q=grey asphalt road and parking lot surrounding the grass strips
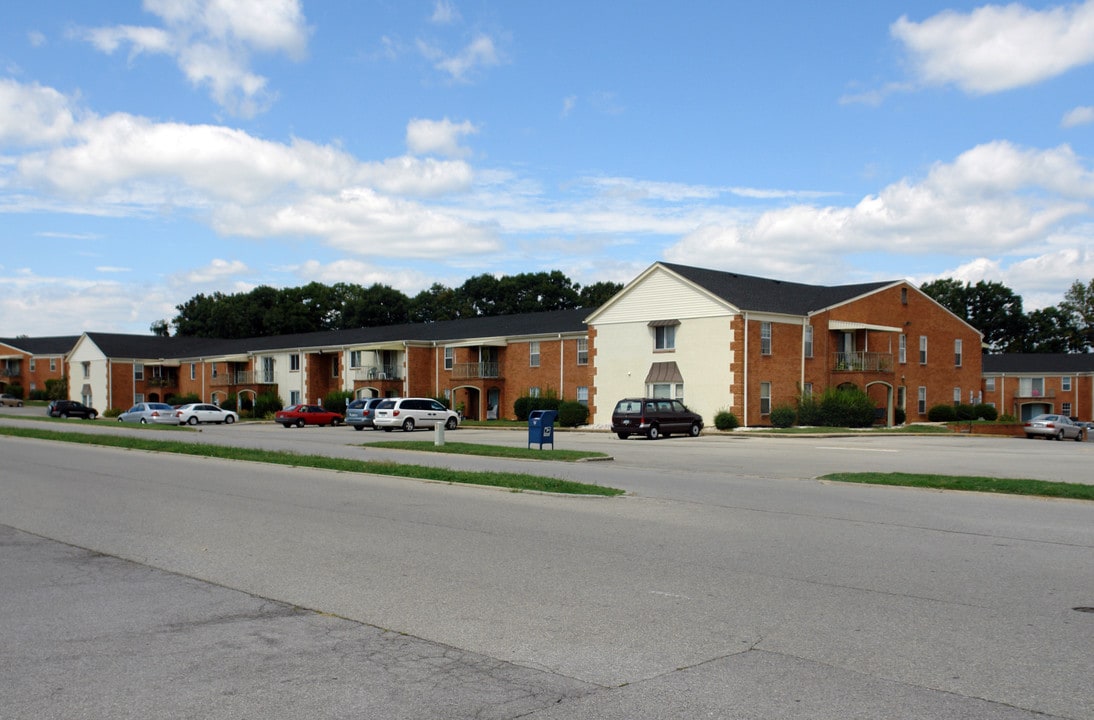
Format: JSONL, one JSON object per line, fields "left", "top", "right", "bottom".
{"left": 6, "top": 411, "right": 1094, "bottom": 719}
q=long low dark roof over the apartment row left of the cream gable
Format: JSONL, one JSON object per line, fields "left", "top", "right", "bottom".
{"left": 70, "top": 309, "right": 590, "bottom": 359}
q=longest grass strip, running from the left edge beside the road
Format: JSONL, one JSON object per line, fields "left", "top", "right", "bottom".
{"left": 0, "top": 428, "right": 624, "bottom": 497}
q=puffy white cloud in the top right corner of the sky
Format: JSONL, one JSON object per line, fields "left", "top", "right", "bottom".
{"left": 891, "top": 0, "right": 1094, "bottom": 94}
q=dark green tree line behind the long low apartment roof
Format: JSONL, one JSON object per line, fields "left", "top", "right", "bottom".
{"left": 160, "top": 270, "right": 622, "bottom": 339}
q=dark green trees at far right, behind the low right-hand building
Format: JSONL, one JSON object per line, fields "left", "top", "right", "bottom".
{"left": 920, "top": 278, "right": 1094, "bottom": 352}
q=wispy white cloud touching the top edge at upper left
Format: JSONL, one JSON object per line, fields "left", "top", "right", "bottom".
{"left": 78, "top": 0, "right": 309, "bottom": 117}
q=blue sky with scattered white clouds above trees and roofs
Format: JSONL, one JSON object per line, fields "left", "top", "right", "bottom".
{"left": 0, "top": 0, "right": 1094, "bottom": 337}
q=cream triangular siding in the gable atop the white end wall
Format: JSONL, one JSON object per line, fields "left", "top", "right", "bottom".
{"left": 594, "top": 268, "right": 732, "bottom": 323}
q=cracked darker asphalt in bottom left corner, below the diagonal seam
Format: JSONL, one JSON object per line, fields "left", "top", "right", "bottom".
{"left": 0, "top": 525, "right": 597, "bottom": 720}
